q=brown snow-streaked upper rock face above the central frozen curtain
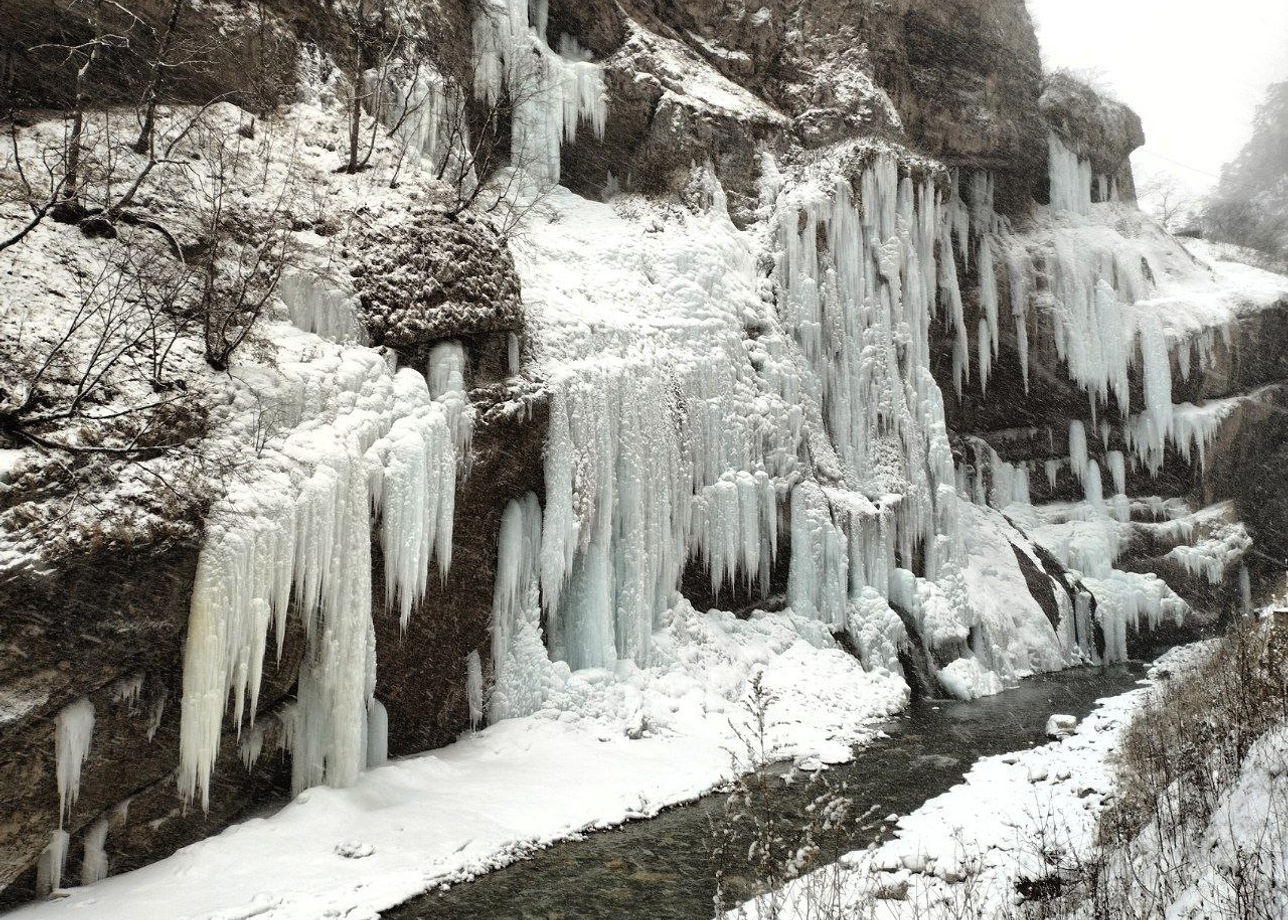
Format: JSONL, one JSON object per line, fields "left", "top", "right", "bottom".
{"left": 561, "top": 0, "right": 1046, "bottom": 219}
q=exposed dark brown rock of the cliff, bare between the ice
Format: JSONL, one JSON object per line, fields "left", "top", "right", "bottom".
{"left": 0, "top": 0, "right": 1288, "bottom": 901}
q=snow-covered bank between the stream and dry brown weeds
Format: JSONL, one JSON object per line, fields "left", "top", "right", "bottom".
{"left": 729, "top": 643, "right": 1211, "bottom": 920}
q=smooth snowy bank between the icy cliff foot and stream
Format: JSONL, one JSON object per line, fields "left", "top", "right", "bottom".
{"left": 13, "top": 607, "right": 907, "bottom": 920}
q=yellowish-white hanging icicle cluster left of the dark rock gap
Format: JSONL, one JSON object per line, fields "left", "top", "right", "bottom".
{"left": 179, "top": 327, "right": 456, "bottom": 807}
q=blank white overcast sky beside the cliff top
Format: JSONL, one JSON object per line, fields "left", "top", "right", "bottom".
{"left": 1028, "top": 0, "right": 1288, "bottom": 189}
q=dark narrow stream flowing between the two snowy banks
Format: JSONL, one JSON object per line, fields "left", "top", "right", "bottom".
{"left": 381, "top": 665, "right": 1144, "bottom": 920}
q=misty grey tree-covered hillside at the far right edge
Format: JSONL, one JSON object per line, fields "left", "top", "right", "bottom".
{"left": 1203, "top": 81, "right": 1288, "bottom": 258}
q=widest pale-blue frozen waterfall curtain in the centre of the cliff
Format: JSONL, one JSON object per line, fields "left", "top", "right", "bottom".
{"left": 492, "top": 152, "right": 1068, "bottom": 719}
